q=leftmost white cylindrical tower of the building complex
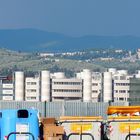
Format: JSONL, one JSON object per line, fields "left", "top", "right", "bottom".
{"left": 15, "top": 71, "right": 24, "bottom": 101}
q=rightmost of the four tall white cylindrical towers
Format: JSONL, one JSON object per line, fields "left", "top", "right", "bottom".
{"left": 103, "top": 72, "right": 112, "bottom": 102}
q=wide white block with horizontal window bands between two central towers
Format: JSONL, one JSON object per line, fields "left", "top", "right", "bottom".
{"left": 51, "top": 78, "right": 82, "bottom": 101}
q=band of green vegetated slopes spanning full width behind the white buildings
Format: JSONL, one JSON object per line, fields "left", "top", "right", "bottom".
{"left": 0, "top": 49, "right": 140, "bottom": 77}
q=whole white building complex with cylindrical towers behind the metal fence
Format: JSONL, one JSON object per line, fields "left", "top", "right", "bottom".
{"left": 0, "top": 68, "right": 140, "bottom": 102}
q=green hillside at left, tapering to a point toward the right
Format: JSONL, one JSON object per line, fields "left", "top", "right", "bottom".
{"left": 0, "top": 49, "right": 104, "bottom": 76}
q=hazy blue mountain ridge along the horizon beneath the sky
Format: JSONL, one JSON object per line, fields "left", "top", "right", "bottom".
{"left": 0, "top": 29, "right": 140, "bottom": 52}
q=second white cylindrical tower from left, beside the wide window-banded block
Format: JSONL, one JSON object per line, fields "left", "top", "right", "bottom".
{"left": 40, "top": 71, "right": 50, "bottom": 102}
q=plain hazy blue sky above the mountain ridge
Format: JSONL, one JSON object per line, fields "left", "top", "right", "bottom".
{"left": 0, "top": 0, "right": 140, "bottom": 36}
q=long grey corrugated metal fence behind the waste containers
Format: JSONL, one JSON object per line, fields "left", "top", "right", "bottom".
{"left": 0, "top": 101, "right": 128, "bottom": 118}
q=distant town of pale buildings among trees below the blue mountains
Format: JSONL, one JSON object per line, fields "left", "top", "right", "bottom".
{"left": 39, "top": 49, "right": 140, "bottom": 62}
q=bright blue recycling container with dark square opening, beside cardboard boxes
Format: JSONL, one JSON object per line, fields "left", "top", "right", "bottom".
{"left": 0, "top": 109, "right": 39, "bottom": 140}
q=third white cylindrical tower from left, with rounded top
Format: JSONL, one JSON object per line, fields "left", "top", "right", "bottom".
{"left": 82, "top": 69, "right": 92, "bottom": 102}
